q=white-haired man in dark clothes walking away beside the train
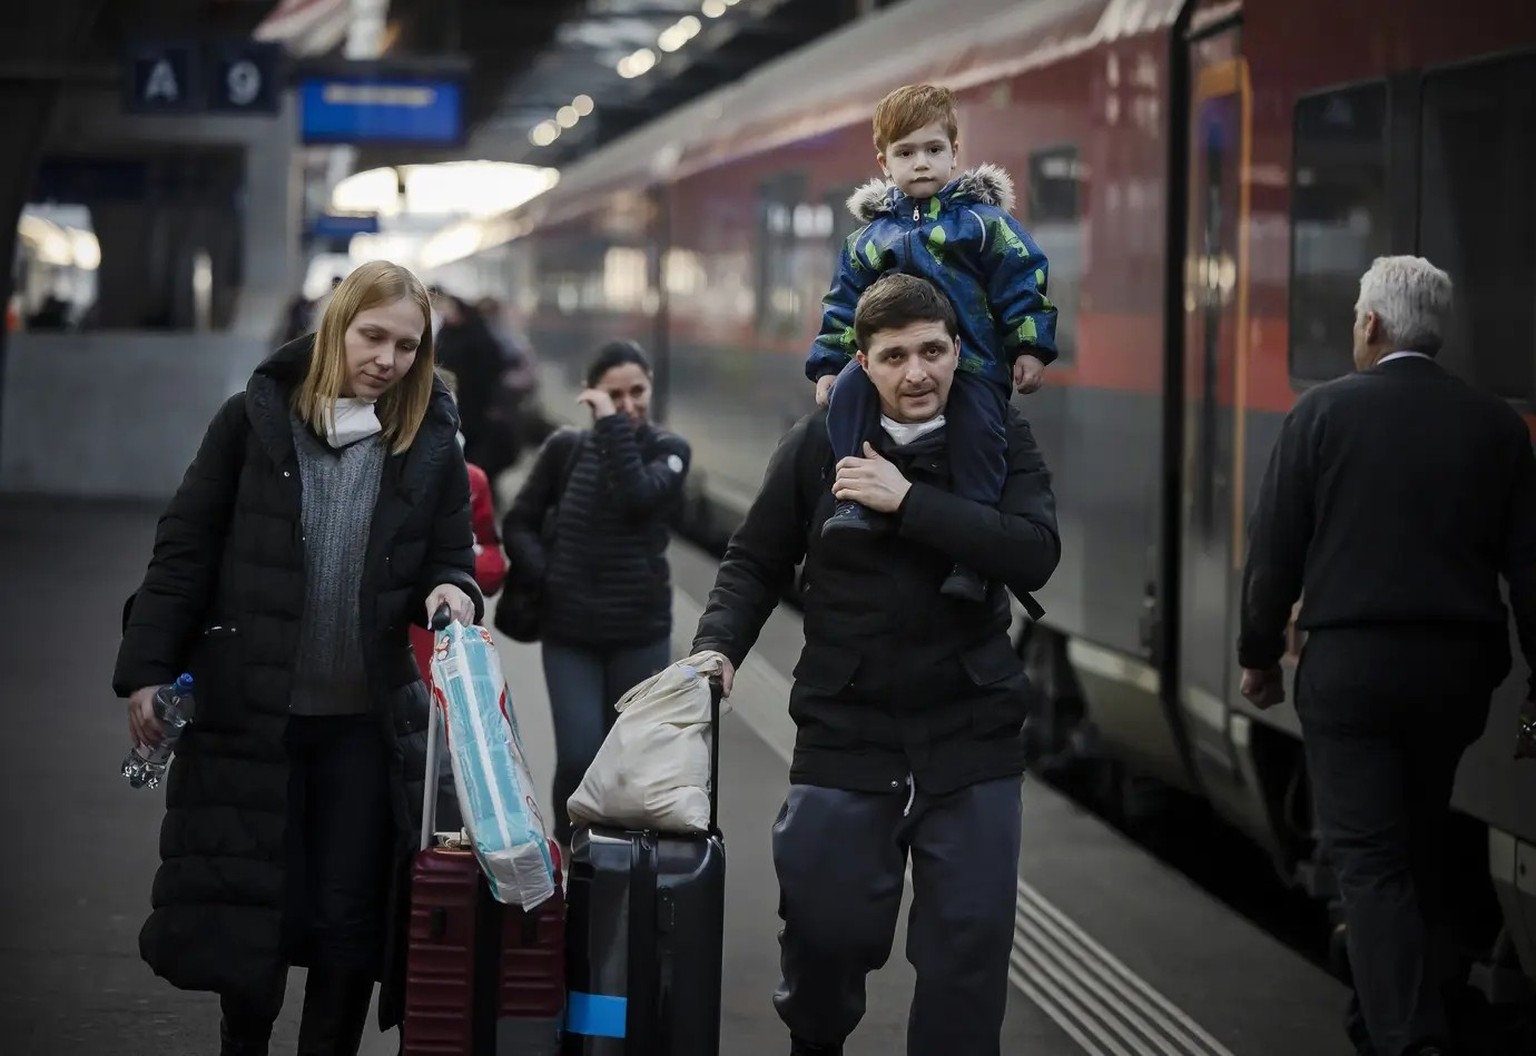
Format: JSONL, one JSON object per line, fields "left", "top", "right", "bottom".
{"left": 1238, "top": 256, "right": 1536, "bottom": 1056}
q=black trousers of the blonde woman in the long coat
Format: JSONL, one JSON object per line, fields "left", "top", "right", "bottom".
{"left": 223, "top": 715, "right": 393, "bottom": 1025}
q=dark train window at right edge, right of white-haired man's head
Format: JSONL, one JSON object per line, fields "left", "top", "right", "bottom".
{"left": 1419, "top": 55, "right": 1536, "bottom": 399}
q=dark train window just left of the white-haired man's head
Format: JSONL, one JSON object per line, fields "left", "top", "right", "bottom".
{"left": 1290, "top": 83, "right": 1390, "bottom": 382}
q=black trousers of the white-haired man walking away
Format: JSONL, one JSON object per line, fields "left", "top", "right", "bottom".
{"left": 1296, "top": 628, "right": 1510, "bottom": 1056}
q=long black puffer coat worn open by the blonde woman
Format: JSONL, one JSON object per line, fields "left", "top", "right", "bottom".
{"left": 112, "top": 336, "right": 482, "bottom": 1027}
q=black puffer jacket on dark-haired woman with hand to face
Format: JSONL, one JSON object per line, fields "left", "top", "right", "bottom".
{"left": 501, "top": 414, "right": 690, "bottom": 646}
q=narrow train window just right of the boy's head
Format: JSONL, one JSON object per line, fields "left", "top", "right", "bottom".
{"left": 1025, "top": 146, "right": 1086, "bottom": 362}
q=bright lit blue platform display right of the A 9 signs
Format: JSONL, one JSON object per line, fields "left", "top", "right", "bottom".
{"left": 300, "top": 77, "right": 464, "bottom": 146}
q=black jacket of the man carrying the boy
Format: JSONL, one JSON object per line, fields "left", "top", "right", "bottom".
{"left": 694, "top": 411, "right": 1060, "bottom": 795}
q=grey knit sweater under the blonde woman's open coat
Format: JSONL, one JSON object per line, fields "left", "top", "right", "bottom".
{"left": 289, "top": 417, "right": 384, "bottom": 715}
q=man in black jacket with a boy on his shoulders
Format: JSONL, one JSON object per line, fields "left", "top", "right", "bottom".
{"left": 693, "top": 273, "right": 1060, "bottom": 1056}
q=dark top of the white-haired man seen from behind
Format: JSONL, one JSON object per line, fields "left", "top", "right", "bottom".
{"left": 1238, "top": 349, "right": 1536, "bottom": 695}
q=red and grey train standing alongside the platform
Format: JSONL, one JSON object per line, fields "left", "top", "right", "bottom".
{"left": 456, "top": 0, "right": 1536, "bottom": 976}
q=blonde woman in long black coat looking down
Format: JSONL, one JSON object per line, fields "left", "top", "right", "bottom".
{"left": 114, "top": 261, "right": 484, "bottom": 1056}
